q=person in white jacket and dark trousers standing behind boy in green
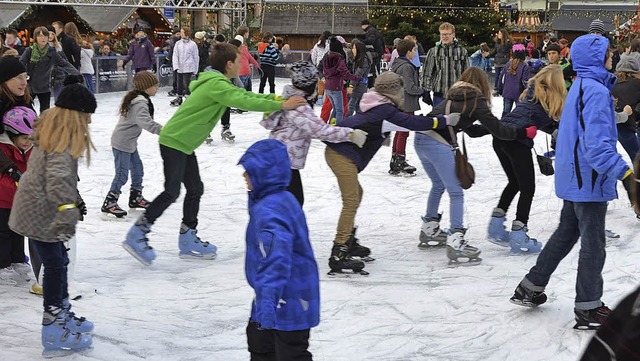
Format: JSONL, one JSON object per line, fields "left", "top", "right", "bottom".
{"left": 171, "top": 26, "right": 200, "bottom": 107}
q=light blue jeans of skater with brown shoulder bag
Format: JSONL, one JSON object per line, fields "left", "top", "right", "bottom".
{"left": 414, "top": 133, "right": 464, "bottom": 229}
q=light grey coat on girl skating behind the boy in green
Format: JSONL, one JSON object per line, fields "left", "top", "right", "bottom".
{"left": 111, "top": 95, "right": 162, "bottom": 153}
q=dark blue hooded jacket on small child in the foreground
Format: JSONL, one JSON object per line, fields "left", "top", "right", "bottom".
{"left": 238, "top": 139, "right": 320, "bottom": 331}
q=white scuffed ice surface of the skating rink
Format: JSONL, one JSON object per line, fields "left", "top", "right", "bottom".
{"left": 0, "top": 79, "right": 640, "bottom": 361}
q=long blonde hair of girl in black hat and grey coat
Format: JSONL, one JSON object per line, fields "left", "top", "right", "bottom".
{"left": 32, "top": 107, "right": 96, "bottom": 164}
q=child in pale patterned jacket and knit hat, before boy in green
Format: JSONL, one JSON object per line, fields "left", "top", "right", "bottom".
{"left": 260, "top": 61, "right": 367, "bottom": 206}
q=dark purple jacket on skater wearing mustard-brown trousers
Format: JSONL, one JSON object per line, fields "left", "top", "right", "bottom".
{"left": 325, "top": 90, "right": 447, "bottom": 173}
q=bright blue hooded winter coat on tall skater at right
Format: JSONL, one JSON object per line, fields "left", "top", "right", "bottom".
{"left": 555, "top": 34, "right": 629, "bottom": 202}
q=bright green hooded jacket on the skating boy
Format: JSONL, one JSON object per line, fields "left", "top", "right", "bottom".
{"left": 160, "top": 70, "right": 282, "bottom": 154}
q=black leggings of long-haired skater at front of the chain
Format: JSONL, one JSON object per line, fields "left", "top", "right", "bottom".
{"left": 493, "top": 138, "right": 536, "bottom": 224}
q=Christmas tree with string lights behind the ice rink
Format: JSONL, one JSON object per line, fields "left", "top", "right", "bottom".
{"left": 369, "top": 0, "right": 510, "bottom": 50}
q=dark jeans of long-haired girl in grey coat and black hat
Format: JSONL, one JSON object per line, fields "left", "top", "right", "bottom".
{"left": 33, "top": 240, "right": 69, "bottom": 310}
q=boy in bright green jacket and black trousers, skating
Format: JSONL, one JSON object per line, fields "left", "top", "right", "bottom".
{"left": 122, "top": 43, "right": 307, "bottom": 265}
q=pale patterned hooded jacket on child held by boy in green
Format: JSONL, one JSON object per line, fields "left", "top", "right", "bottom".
{"left": 260, "top": 85, "right": 353, "bottom": 169}
